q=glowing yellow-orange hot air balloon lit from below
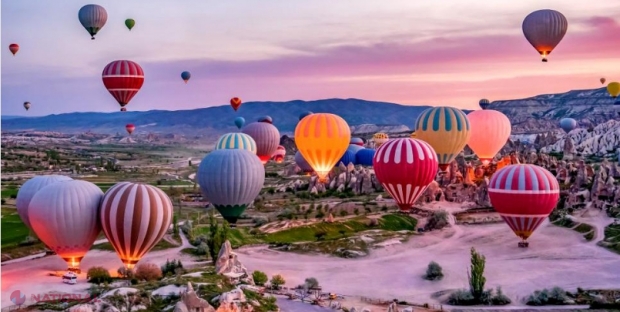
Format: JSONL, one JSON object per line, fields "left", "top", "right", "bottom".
{"left": 295, "top": 113, "right": 351, "bottom": 182}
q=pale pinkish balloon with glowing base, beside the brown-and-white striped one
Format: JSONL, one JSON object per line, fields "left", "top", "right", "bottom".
{"left": 28, "top": 180, "right": 103, "bottom": 270}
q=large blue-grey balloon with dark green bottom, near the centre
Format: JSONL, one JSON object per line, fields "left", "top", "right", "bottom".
{"left": 196, "top": 149, "right": 265, "bottom": 224}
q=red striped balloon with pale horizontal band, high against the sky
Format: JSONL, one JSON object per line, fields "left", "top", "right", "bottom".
{"left": 101, "top": 60, "right": 144, "bottom": 111}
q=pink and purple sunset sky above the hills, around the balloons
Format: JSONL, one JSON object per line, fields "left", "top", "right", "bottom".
{"left": 1, "top": 0, "right": 620, "bottom": 116}
